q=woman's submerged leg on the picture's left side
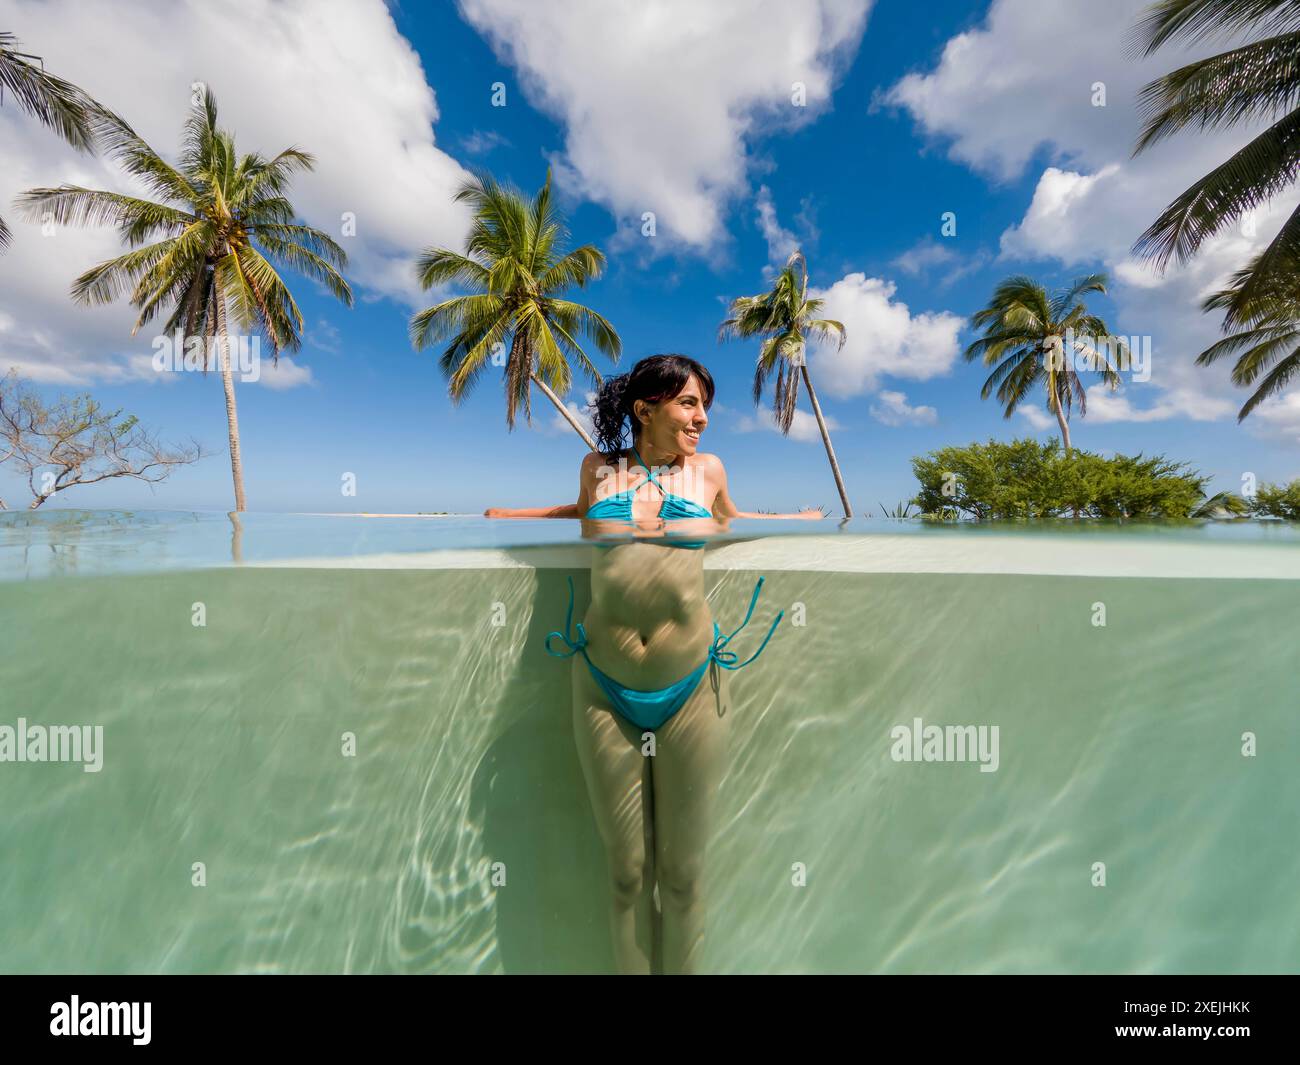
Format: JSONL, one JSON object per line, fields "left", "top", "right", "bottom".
{"left": 573, "top": 654, "right": 655, "bottom": 974}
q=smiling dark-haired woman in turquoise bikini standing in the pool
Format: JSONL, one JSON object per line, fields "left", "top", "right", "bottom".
{"left": 486, "top": 355, "right": 822, "bottom": 973}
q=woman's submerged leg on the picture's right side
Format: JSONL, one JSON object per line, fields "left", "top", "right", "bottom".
{"left": 654, "top": 666, "right": 731, "bottom": 973}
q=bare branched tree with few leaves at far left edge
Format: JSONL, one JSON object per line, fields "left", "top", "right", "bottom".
{"left": 0, "top": 371, "right": 203, "bottom": 510}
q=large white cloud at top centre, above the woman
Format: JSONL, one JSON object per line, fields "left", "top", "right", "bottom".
{"left": 460, "top": 0, "right": 871, "bottom": 252}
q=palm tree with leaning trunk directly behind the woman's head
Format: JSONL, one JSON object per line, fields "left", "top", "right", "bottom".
{"left": 411, "top": 170, "right": 623, "bottom": 451}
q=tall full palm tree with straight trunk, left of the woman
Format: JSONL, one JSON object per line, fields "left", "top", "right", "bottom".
{"left": 18, "top": 90, "right": 352, "bottom": 511}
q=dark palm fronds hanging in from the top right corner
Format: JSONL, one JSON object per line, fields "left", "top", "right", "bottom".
{"left": 1134, "top": 0, "right": 1300, "bottom": 308}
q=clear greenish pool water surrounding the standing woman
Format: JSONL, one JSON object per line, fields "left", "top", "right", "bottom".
{"left": 0, "top": 511, "right": 1300, "bottom": 973}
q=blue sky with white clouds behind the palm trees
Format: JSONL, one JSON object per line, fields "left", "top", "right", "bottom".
{"left": 0, "top": 0, "right": 1300, "bottom": 514}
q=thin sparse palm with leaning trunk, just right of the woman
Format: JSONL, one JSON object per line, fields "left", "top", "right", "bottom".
{"left": 718, "top": 251, "right": 853, "bottom": 518}
